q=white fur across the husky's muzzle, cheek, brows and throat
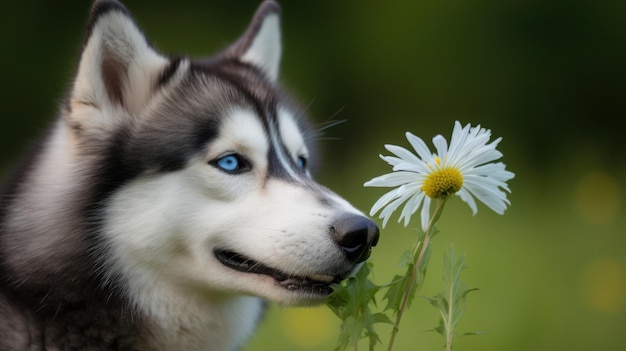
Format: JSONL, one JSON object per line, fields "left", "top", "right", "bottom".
{"left": 99, "top": 109, "right": 366, "bottom": 350}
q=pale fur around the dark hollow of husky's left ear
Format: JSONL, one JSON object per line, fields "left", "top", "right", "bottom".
{"left": 70, "top": 11, "right": 167, "bottom": 130}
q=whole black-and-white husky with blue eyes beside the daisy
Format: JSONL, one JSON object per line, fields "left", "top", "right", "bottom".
{"left": 0, "top": 0, "right": 378, "bottom": 351}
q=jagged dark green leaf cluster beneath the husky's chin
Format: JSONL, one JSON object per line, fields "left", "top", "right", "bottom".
{"left": 326, "top": 263, "right": 393, "bottom": 350}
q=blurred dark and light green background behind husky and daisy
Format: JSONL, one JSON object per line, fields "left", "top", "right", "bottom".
{"left": 0, "top": 0, "right": 626, "bottom": 351}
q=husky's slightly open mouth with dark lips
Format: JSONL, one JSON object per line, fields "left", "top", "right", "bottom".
{"left": 215, "top": 250, "right": 345, "bottom": 296}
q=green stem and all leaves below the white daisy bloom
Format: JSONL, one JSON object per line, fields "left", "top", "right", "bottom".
{"left": 327, "top": 201, "right": 477, "bottom": 351}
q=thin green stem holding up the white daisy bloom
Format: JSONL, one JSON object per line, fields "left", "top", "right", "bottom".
{"left": 387, "top": 197, "right": 447, "bottom": 351}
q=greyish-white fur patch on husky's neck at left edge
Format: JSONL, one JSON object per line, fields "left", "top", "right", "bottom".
{"left": 4, "top": 123, "right": 79, "bottom": 275}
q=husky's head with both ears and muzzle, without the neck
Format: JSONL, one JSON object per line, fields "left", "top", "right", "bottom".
{"left": 70, "top": 1, "right": 378, "bottom": 304}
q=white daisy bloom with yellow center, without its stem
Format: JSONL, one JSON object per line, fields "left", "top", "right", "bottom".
{"left": 364, "top": 121, "right": 515, "bottom": 230}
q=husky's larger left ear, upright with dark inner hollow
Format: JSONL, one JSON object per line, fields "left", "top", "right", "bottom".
{"left": 71, "top": 0, "right": 168, "bottom": 123}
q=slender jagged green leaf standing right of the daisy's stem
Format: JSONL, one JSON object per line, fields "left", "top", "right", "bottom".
{"left": 428, "top": 244, "right": 478, "bottom": 350}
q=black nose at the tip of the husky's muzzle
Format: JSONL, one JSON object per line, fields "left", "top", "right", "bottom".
{"left": 332, "top": 215, "right": 379, "bottom": 263}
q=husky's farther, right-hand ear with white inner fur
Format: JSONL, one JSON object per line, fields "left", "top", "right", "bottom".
{"left": 228, "top": 0, "right": 282, "bottom": 82}
